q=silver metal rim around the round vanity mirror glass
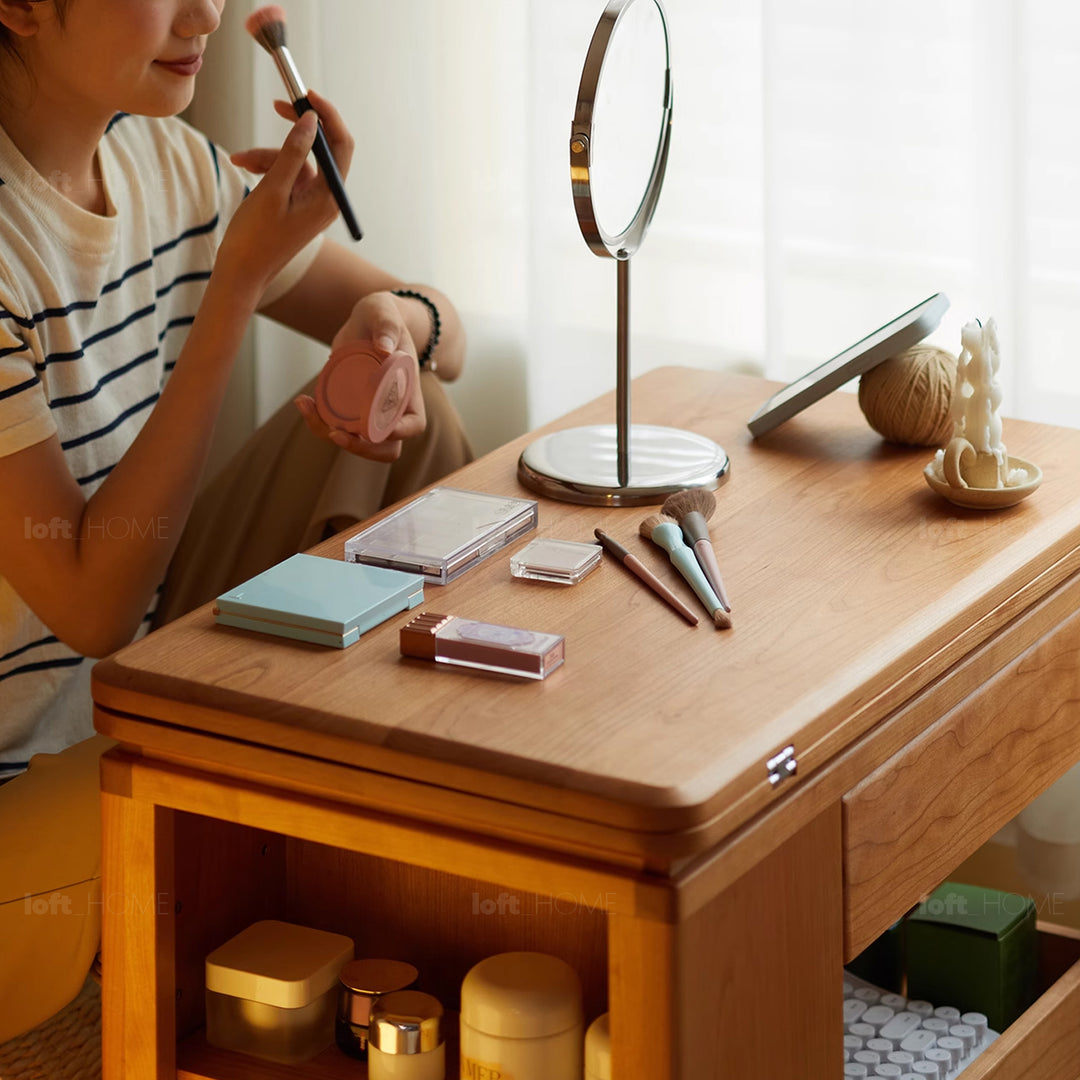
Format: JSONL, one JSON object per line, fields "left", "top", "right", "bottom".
{"left": 570, "top": 0, "right": 674, "bottom": 259}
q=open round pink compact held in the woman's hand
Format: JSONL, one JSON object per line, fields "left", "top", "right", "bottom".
{"left": 315, "top": 341, "right": 416, "bottom": 443}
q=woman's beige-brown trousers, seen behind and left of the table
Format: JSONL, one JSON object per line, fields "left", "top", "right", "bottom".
{"left": 0, "top": 373, "right": 472, "bottom": 1042}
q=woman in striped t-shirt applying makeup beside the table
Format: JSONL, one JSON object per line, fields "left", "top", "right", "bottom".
{"left": 0, "top": 0, "right": 470, "bottom": 1041}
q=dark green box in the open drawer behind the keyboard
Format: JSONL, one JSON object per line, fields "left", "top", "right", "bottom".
{"left": 907, "top": 881, "right": 1038, "bottom": 1031}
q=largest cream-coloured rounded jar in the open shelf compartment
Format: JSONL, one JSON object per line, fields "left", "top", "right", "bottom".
{"left": 461, "top": 953, "right": 583, "bottom": 1080}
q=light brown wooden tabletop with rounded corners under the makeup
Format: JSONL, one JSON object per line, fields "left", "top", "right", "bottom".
{"left": 94, "top": 368, "right": 1080, "bottom": 851}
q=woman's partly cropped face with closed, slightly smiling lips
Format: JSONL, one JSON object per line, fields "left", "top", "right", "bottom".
{"left": 21, "top": 0, "right": 226, "bottom": 122}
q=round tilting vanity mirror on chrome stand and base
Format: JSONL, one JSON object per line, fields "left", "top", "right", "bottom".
{"left": 517, "top": 0, "right": 728, "bottom": 507}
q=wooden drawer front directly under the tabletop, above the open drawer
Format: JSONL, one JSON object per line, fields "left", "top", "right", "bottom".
{"left": 843, "top": 613, "right": 1080, "bottom": 960}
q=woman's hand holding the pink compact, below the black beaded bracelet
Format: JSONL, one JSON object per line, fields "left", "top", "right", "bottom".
{"left": 295, "top": 293, "right": 428, "bottom": 461}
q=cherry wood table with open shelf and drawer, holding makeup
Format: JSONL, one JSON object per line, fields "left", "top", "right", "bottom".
{"left": 94, "top": 368, "right": 1080, "bottom": 1080}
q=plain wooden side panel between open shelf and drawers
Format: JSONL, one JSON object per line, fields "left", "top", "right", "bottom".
{"left": 673, "top": 806, "right": 843, "bottom": 1080}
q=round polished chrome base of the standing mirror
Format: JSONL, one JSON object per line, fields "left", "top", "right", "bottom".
{"left": 517, "top": 423, "right": 731, "bottom": 507}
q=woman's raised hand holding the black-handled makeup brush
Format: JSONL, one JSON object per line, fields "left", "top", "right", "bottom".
{"left": 217, "top": 92, "right": 353, "bottom": 294}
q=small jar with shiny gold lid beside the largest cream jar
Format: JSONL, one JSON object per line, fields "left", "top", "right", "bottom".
{"left": 367, "top": 990, "right": 446, "bottom": 1080}
